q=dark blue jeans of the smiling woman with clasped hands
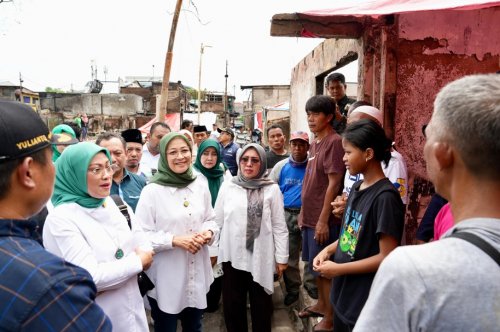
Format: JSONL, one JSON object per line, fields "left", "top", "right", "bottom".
{"left": 148, "top": 296, "right": 203, "bottom": 332}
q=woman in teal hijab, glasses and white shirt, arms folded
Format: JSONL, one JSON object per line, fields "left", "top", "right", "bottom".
{"left": 43, "top": 142, "right": 153, "bottom": 332}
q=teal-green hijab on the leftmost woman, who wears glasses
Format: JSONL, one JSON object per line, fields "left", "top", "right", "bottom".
{"left": 52, "top": 142, "right": 111, "bottom": 208}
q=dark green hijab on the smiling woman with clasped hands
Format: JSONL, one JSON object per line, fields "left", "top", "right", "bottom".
{"left": 151, "top": 132, "right": 196, "bottom": 188}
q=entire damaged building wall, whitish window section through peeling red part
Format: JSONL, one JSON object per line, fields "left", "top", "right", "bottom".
{"left": 291, "top": 7, "right": 500, "bottom": 243}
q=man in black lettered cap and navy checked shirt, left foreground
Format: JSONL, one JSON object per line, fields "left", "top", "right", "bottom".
{"left": 0, "top": 101, "right": 111, "bottom": 331}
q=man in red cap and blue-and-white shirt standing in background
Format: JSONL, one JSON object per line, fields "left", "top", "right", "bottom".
{"left": 269, "top": 131, "right": 317, "bottom": 306}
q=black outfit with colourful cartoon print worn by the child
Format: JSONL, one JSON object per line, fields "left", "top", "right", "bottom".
{"left": 331, "top": 178, "right": 404, "bottom": 325}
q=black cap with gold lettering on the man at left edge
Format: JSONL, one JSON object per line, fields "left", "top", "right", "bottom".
{"left": 0, "top": 101, "right": 56, "bottom": 162}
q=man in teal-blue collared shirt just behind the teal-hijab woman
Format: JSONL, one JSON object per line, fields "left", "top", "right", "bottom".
{"left": 96, "top": 133, "right": 146, "bottom": 212}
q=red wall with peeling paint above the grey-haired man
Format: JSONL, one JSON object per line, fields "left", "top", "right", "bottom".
{"left": 395, "top": 7, "right": 500, "bottom": 178}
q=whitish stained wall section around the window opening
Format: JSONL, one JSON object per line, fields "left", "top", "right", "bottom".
{"left": 290, "top": 39, "right": 362, "bottom": 131}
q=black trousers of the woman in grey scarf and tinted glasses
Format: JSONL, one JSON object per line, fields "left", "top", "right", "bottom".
{"left": 222, "top": 262, "right": 273, "bottom": 332}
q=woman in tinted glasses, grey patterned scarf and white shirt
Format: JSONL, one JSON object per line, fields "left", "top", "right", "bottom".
{"left": 215, "top": 143, "right": 288, "bottom": 332}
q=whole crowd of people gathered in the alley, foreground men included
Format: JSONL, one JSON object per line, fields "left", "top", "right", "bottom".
{"left": 0, "top": 73, "right": 500, "bottom": 332}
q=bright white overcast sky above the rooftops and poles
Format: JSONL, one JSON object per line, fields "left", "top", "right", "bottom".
{"left": 0, "top": 0, "right": 356, "bottom": 101}
